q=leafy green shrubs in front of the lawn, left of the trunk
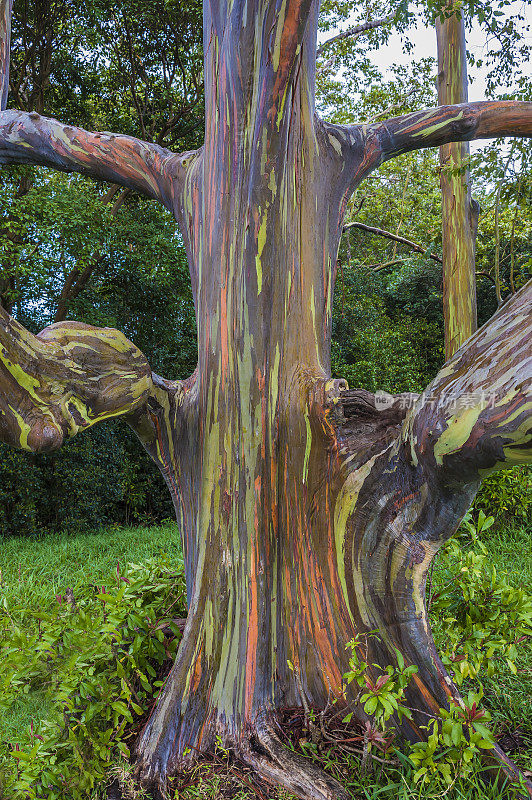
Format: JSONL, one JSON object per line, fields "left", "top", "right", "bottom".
{"left": 0, "top": 559, "right": 186, "bottom": 800}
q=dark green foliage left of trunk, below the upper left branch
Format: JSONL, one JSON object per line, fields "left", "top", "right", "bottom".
{"left": 0, "top": 174, "right": 196, "bottom": 535}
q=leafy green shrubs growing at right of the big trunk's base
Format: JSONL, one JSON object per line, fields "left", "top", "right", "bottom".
{"left": 332, "top": 510, "right": 532, "bottom": 797}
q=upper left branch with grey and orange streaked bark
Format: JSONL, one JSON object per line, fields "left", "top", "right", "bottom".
{"left": 0, "top": 110, "right": 197, "bottom": 211}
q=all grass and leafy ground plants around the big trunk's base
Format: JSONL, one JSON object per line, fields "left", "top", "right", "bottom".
{"left": 0, "top": 511, "right": 532, "bottom": 800}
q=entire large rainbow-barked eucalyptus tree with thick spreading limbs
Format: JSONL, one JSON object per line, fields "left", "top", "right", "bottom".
{"left": 0, "top": 0, "right": 532, "bottom": 798}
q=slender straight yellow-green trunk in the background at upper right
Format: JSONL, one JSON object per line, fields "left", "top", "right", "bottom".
{"left": 436, "top": 7, "right": 478, "bottom": 358}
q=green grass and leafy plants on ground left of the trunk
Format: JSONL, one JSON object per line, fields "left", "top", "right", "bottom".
{"left": 0, "top": 525, "right": 186, "bottom": 800}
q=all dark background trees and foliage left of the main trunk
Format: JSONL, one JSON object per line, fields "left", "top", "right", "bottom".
{"left": 0, "top": 0, "right": 203, "bottom": 535}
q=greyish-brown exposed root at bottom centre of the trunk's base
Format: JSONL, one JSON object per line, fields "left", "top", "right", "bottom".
{"left": 236, "top": 720, "right": 349, "bottom": 800}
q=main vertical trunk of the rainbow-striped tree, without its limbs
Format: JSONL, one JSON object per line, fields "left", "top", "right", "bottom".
{"left": 131, "top": 7, "right": 355, "bottom": 792}
